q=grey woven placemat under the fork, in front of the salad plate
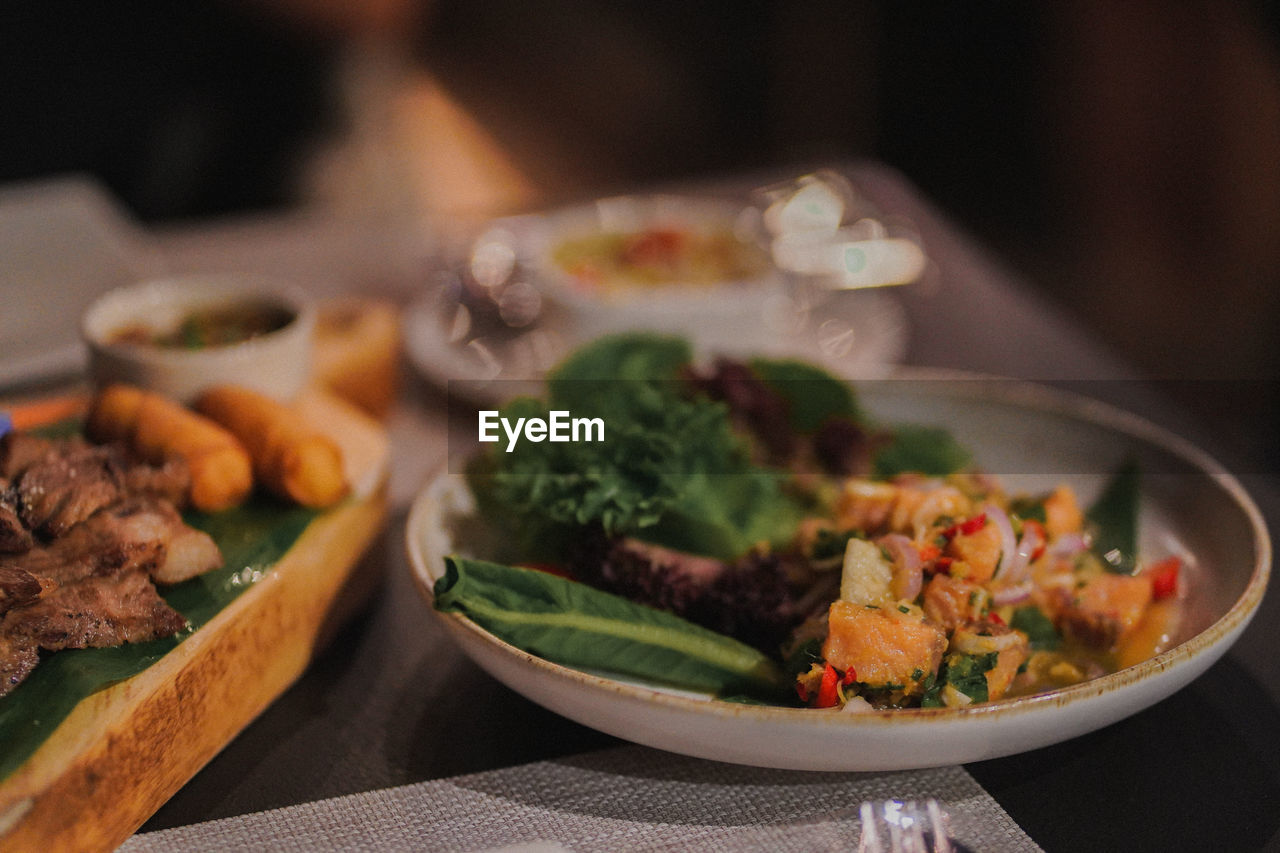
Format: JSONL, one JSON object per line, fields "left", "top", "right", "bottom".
{"left": 122, "top": 745, "right": 1039, "bottom": 853}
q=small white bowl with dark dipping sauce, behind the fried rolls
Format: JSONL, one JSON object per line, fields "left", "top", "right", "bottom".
{"left": 81, "top": 274, "right": 316, "bottom": 402}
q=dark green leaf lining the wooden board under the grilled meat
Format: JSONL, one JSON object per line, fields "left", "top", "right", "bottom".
{"left": 0, "top": 497, "right": 316, "bottom": 779}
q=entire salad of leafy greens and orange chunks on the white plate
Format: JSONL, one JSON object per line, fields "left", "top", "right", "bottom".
{"left": 435, "top": 334, "right": 1185, "bottom": 712}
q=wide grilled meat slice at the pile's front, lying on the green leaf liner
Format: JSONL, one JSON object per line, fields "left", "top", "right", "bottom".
{"left": 0, "top": 571, "right": 187, "bottom": 651}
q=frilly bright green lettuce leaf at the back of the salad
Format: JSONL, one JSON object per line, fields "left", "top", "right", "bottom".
{"left": 467, "top": 336, "right": 804, "bottom": 560}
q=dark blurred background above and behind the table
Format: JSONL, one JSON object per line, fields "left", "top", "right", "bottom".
{"left": 0, "top": 0, "right": 1280, "bottom": 452}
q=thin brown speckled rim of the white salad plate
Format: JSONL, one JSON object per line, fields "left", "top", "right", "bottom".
{"left": 406, "top": 369, "right": 1271, "bottom": 727}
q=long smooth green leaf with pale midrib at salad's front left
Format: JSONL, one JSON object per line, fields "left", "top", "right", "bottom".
{"left": 435, "top": 557, "right": 786, "bottom": 695}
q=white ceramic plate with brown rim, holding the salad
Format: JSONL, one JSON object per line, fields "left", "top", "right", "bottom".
{"left": 407, "top": 374, "right": 1271, "bottom": 771}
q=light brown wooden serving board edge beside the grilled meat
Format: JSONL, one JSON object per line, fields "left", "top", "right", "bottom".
{"left": 0, "top": 391, "right": 389, "bottom": 853}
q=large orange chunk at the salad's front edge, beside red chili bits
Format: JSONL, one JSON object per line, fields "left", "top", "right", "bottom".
{"left": 822, "top": 601, "right": 947, "bottom": 694}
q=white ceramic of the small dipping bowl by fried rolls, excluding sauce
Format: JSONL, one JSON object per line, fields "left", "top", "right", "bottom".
{"left": 81, "top": 274, "right": 315, "bottom": 402}
